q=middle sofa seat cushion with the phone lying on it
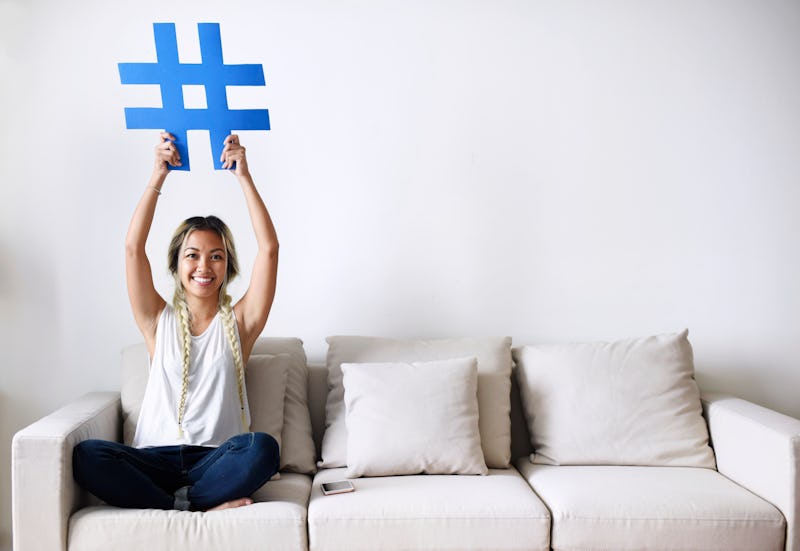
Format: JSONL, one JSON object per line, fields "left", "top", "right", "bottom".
{"left": 308, "top": 467, "right": 550, "bottom": 551}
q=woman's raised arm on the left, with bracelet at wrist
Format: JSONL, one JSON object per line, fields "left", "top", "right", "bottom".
{"left": 125, "top": 132, "right": 180, "bottom": 356}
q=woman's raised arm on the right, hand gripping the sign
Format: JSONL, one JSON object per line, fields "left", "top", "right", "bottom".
{"left": 222, "top": 134, "right": 278, "bottom": 359}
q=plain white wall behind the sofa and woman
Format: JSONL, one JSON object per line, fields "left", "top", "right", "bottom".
{"left": 0, "top": 0, "right": 800, "bottom": 547}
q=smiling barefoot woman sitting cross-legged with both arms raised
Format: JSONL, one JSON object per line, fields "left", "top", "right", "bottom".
{"left": 73, "top": 133, "right": 280, "bottom": 511}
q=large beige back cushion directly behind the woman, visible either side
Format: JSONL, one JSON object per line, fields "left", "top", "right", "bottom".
{"left": 121, "top": 337, "right": 317, "bottom": 473}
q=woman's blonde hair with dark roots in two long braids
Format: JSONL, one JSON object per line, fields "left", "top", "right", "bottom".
{"left": 167, "top": 216, "right": 250, "bottom": 438}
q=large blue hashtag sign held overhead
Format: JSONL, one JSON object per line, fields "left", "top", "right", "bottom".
{"left": 119, "top": 23, "right": 269, "bottom": 170}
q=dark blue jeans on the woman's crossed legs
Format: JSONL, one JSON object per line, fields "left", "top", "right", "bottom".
{"left": 72, "top": 432, "right": 280, "bottom": 511}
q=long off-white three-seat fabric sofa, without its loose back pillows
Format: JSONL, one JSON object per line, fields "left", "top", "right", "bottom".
{"left": 12, "top": 339, "right": 800, "bottom": 551}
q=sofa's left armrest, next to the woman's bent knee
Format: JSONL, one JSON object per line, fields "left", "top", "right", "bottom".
{"left": 11, "top": 392, "right": 122, "bottom": 551}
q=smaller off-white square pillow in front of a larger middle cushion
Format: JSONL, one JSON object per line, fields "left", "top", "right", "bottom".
{"left": 342, "top": 358, "right": 488, "bottom": 478}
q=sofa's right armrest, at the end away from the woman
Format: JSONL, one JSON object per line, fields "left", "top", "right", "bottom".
{"left": 702, "top": 393, "right": 800, "bottom": 551}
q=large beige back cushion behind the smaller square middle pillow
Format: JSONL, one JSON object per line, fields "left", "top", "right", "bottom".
{"left": 319, "top": 336, "right": 511, "bottom": 469}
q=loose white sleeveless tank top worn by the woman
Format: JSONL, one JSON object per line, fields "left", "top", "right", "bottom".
{"left": 133, "top": 305, "right": 250, "bottom": 448}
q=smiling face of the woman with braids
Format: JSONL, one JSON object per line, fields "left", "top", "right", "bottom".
{"left": 178, "top": 230, "right": 228, "bottom": 298}
